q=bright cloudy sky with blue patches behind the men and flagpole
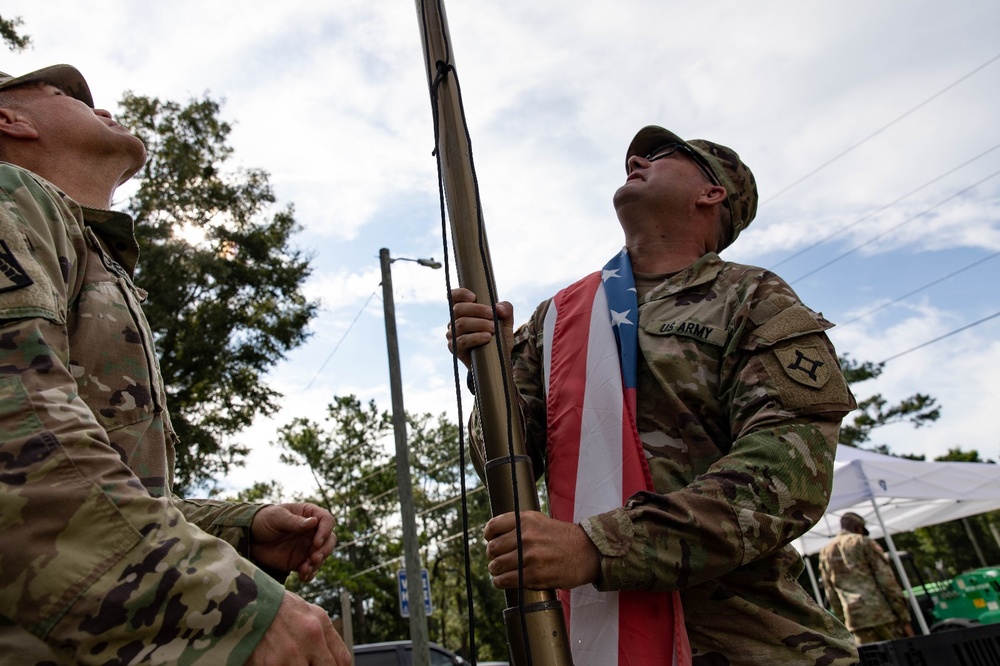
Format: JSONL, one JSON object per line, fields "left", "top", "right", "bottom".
{"left": 0, "top": 0, "right": 1000, "bottom": 493}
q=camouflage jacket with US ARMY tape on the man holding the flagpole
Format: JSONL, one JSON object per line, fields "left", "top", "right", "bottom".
{"left": 472, "top": 254, "right": 858, "bottom": 665}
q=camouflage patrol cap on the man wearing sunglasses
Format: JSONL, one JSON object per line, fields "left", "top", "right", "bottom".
{"left": 625, "top": 125, "right": 757, "bottom": 252}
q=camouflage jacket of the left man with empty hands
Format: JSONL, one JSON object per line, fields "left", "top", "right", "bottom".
{"left": 0, "top": 164, "right": 284, "bottom": 665}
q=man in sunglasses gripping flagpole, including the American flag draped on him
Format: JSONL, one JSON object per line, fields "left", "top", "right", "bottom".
{"left": 447, "top": 126, "right": 858, "bottom": 666}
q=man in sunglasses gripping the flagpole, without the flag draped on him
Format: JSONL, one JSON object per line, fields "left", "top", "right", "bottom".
{"left": 447, "top": 126, "right": 858, "bottom": 666}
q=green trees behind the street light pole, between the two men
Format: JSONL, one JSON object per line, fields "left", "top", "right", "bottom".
{"left": 274, "top": 396, "right": 506, "bottom": 658}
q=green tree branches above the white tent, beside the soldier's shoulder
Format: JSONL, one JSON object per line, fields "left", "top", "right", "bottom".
{"left": 840, "top": 355, "right": 941, "bottom": 453}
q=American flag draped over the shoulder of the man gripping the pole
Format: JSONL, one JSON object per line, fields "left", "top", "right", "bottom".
{"left": 543, "top": 250, "right": 690, "bottom": 666}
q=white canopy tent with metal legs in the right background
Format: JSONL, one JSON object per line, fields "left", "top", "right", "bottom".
{"left": 793, "top": 446, "right": 1000, "bottom": 633}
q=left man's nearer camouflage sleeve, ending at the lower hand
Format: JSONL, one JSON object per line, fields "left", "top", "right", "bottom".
{"left": 0, "top": 179, "right": 284, "bottom": 664}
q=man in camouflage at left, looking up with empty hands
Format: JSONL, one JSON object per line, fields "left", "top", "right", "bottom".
{"left": 0, "top": 65, "right": 350, "bottom": 666}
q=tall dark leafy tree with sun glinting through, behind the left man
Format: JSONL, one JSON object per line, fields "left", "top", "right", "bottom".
{"left": 119, "top": 93, "right": 316, "bottom": 492}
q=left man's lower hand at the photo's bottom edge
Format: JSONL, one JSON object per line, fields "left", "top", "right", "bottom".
{"left": 247, "top": 592, "right": 351, "bottom": 666}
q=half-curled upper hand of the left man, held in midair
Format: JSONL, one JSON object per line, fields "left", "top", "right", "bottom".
{"left": 250, "top": 502, "right": 337, "bottom": 582}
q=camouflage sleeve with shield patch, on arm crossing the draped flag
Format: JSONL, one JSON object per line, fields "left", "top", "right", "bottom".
{"left": 581, "top": 294, "right": 854, "bottom": 590}
